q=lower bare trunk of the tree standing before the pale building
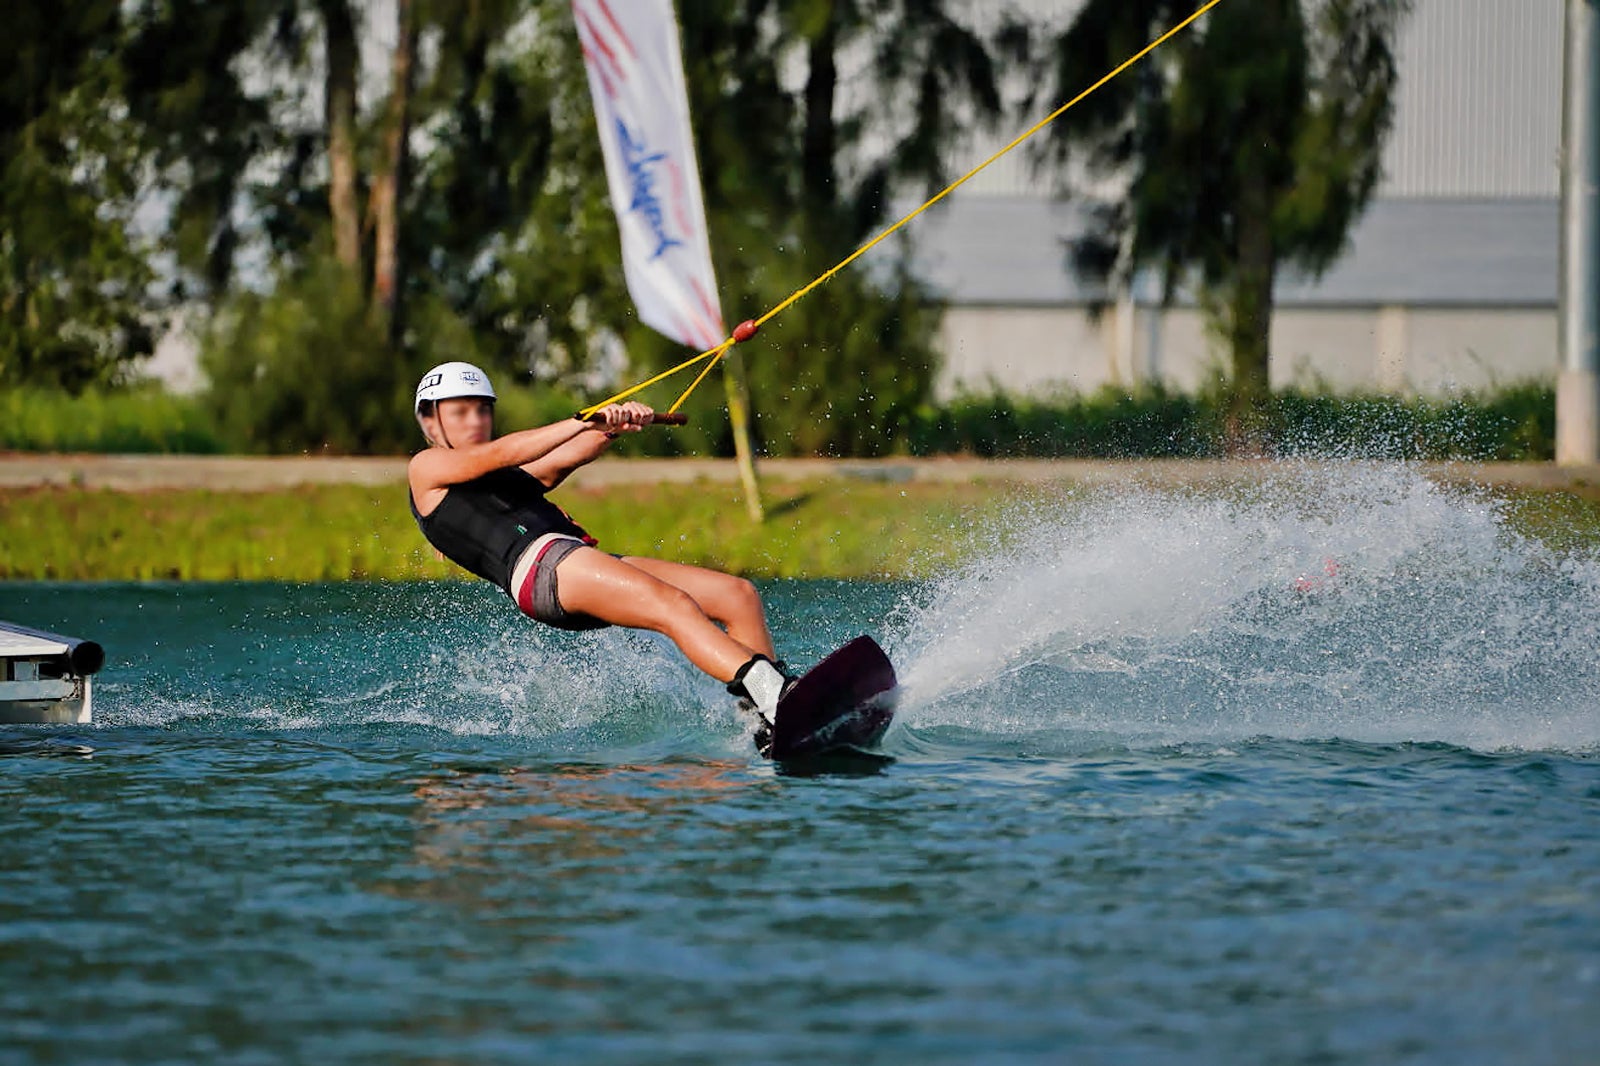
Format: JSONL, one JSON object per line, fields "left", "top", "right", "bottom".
{"left": 1224, "top": 160, "right": 1277, "bottom": 456}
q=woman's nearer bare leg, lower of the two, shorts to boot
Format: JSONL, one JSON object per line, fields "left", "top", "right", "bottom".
{"left": 557, "top": 549, "right": 771, "bottom": 682}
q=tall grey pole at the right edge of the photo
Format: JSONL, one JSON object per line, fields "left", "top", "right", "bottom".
{"left": 1555, "top": 0, "right": 1600, "bottom": 466}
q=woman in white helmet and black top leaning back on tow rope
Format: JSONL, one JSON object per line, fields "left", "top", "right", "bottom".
{"left": 410, "top": 362, "right": 792, "bottom": 723}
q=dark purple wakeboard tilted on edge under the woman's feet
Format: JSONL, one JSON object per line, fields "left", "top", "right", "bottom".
{"left": 765, "top": 637, "right": 899, "bottom": 760}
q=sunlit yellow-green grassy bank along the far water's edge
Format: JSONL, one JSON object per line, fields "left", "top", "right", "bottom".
{"left": 0, "top": 479, "right": 1600, "bottom": 581}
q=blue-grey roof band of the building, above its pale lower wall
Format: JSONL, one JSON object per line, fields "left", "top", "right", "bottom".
{"left": 912, "top": 195, "right": 1560, "bottom": 307}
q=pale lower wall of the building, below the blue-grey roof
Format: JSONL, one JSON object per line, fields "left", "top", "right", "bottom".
{"left": 938, "top": 306, "right": 1560, "bottom": 399}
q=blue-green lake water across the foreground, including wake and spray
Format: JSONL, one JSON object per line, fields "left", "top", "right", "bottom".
{"left": 0, "top": 467, "right": 1600, "bottom": 1064}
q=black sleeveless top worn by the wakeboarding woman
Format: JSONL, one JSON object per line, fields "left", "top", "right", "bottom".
{"left": 406, "top": 466, "right": 595, "bottom": 597}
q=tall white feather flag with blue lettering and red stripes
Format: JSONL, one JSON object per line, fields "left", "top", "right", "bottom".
{"left": 573, "top": 0, "right": 726, "bottom": 351}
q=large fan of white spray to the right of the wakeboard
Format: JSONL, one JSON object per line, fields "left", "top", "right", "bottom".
{"left": 894, "top": 464, "right": 1600, "bottom": 749}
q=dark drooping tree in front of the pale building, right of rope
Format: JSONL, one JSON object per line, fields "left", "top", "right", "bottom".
{"left": 1042, "top": 0, "right": 1411, "bottom": 451}
